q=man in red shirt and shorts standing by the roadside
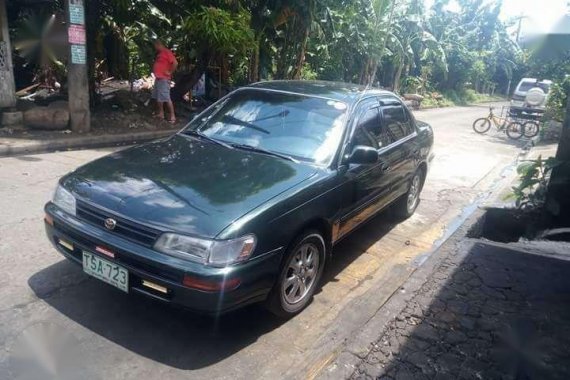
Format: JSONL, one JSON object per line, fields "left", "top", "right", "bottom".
{"left": 152, "top": 40, "right": 178, "bottom": 124}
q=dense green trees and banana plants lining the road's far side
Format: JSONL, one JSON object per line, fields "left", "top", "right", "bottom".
{"left": 8, "top": 0, "right": 566, "bottom": 115}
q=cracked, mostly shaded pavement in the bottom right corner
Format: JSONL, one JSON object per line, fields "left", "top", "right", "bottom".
{"left": 352, "top": 243, "right": 570, "bottom": 380}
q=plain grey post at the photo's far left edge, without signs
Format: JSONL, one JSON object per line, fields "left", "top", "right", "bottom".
{"left": 0, "top": 0, "right": 16, "bottom": 108}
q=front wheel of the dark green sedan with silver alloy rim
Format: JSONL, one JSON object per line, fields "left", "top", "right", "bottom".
{"left": 267, "top": 230, "right": 326, "bottom": 318}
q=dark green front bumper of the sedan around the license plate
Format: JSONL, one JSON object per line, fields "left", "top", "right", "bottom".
{"left": 45, "top": 203, "right": 282, "bottom": 314}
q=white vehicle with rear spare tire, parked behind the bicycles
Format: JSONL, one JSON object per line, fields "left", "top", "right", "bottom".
{"left": 511, "top": 78, "right": 552, "bottom": 114}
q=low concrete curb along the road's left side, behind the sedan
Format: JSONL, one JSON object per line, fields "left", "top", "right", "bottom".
{"left": 0, "top": 128, "right": 179, "bottom": 157}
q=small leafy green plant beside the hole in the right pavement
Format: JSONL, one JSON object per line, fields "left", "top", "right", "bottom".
{"left": 512, "top": 156, "right": 559, "bottom": 208}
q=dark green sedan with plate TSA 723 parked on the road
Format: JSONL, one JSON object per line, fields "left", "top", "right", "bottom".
{"left": 45, "top": 81, "right": 433, "bottom": 317}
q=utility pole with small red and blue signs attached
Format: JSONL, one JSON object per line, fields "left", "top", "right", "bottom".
{"left": 65, "top": 0, "right": 91, "bottom": 132}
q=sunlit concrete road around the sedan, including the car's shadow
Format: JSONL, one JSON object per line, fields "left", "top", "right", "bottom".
{"left": 0, "top": 102, "right": 520, "bottom": 379}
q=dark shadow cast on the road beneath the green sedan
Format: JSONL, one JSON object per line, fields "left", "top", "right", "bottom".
{"left": 28, "top": 212, "right": 394, "bottom": 370}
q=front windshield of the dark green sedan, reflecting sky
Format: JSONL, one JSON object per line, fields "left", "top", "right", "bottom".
{"left": 182, "top": 89, "right": 347, "bottom": 164}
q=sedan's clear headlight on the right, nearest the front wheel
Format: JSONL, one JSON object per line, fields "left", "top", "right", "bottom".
{"left": 154, "top": 233, "right": 256, "bottom": 266}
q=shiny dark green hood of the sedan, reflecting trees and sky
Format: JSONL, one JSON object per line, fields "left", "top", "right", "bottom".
{"left": 63, "top": 135, "right": 316, "bottom": 237}
